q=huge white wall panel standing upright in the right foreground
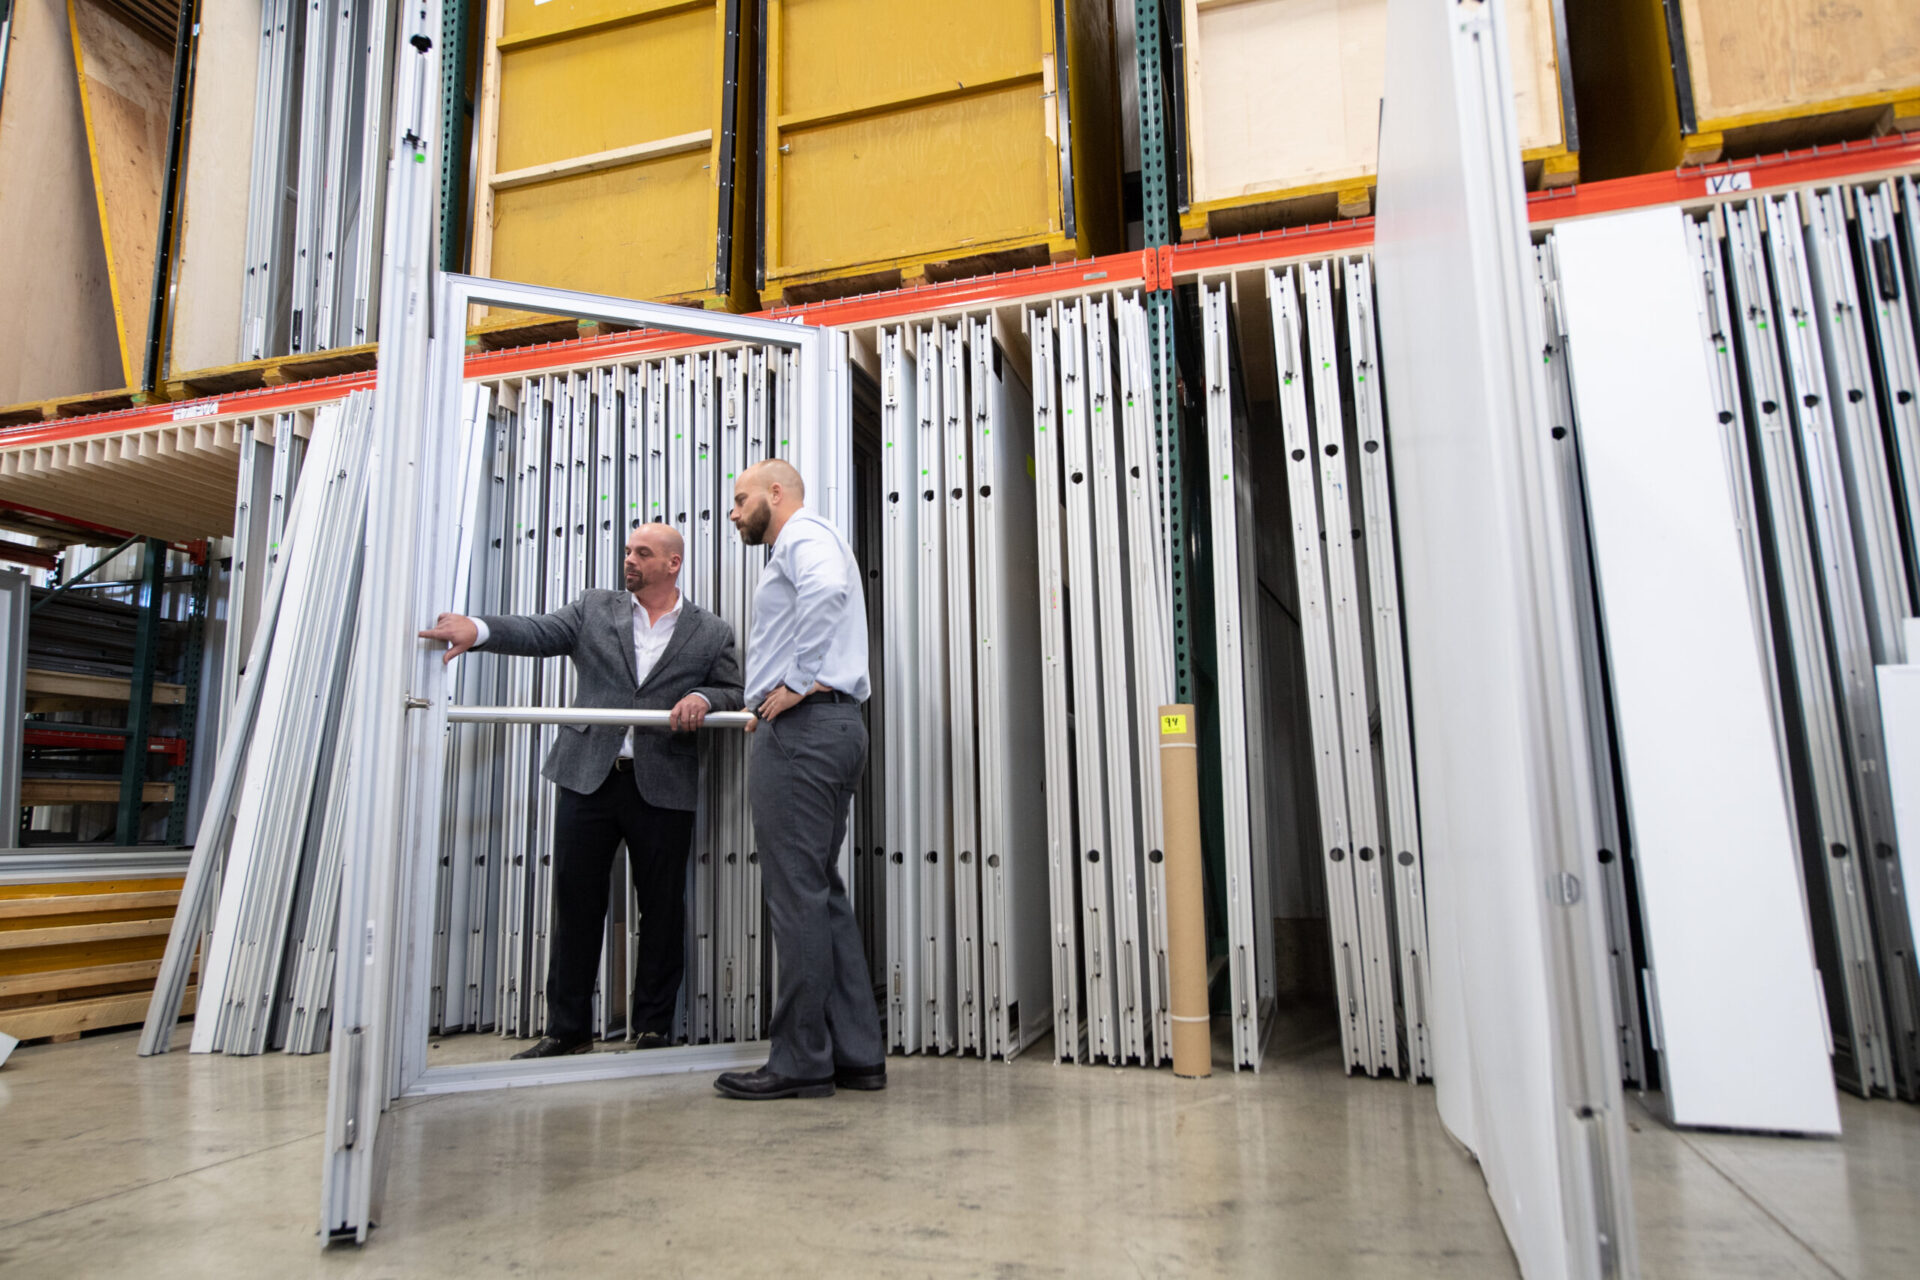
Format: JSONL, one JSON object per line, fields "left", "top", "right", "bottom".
{"left": 1377, "top": 0, "right": 1638, "bottom": 1278}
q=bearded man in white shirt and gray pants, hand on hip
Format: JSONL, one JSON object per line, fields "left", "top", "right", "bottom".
{"left": 714, "top": 459, "right": 887, "bottom": 1100}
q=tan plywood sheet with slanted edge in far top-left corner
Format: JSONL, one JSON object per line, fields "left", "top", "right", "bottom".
{"left": 0, "top": 0, "right": 123, "bottom": 404}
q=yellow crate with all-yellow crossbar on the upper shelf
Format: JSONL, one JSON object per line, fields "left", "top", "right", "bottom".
{"left": 760, "top": 0, "right": 1121, "bottom": 303}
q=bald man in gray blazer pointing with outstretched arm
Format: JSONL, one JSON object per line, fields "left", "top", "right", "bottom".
{"left": 420, "top": 524, "right": 741, "bottom": 1057}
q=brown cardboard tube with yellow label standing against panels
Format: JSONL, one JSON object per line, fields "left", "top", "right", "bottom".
{"left": 1160, "top": 702, "right": 1213, "bottom": 1077}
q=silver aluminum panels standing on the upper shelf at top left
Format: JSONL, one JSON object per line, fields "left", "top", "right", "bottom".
{"left": 238, "top": 0, "right": 399, "bottom": 361}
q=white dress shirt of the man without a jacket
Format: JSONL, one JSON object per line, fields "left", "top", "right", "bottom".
{"left": 747, "top": 507, "right": 868, "bottom": 706}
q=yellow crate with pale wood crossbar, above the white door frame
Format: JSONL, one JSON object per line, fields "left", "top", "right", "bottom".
{"left": 472, "top": 0, "right": 756, "bottom": 324}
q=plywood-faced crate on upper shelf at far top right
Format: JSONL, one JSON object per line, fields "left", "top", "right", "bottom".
{"left": 1569, "top": 0, "right": 1920, "bottom": 178}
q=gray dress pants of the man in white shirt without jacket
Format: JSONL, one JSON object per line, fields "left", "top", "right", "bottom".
{"left": 749, "top": 700, "right": 885, "bottom": 1080}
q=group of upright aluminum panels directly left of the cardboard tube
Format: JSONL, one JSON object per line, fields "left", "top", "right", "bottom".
{"left": 1027, "top": 294, "right": 1173, "bottom": 1065}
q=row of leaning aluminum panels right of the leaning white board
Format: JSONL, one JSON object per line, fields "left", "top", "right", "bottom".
{"left": 1693, "top": 192, "right": 1920, "bottom": 1098}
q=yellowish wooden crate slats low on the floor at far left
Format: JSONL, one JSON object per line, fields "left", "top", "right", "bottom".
{"left": 0, "top": 877, "right": 192, "bottom": 1040}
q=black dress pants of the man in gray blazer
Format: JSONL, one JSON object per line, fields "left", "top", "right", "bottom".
{"left": 547, "top": 770, "right": 693, "bottom": 1040}
